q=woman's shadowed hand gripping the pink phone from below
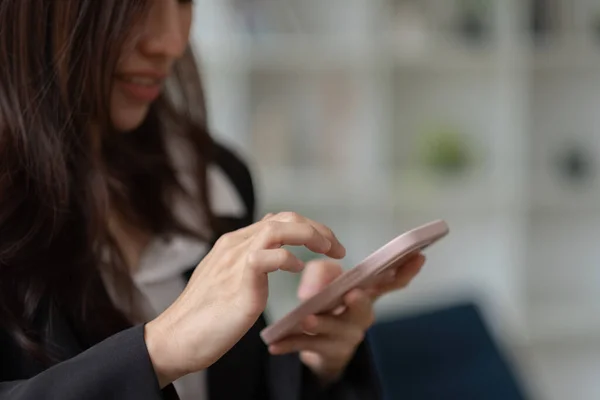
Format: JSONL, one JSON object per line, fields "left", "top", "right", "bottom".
{"left": 269, "top": 254, "right": 425, "bottom": 384}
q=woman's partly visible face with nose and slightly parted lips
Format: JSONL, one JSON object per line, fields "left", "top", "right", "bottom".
{"left": 110, "top": 0, "right": 192, "bottom": 132}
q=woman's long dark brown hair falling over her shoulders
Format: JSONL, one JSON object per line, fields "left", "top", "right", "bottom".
{"left": 0, "top": 0, "right": 216, "bottom": 359}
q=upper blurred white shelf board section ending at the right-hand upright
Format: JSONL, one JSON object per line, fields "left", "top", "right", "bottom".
{"left": 199, "top": 34, "right": 505, "bottom": 73}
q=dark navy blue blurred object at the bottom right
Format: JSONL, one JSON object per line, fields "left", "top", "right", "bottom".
{"left": 369, "top": 304, "right": 528, "bottom": 400}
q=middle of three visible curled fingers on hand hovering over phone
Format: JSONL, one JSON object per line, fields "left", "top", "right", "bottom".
{"left": 254, "top": 220, "right": 331, "bottom": 254}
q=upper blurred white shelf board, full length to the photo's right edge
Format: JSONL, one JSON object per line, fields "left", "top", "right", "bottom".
{"left": 198, "top": 35, "right": 600, "bottom": 73}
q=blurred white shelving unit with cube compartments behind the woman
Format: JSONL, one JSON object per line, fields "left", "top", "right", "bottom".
{"left": 200, "top": 6, "right": 600, "bottom": 390}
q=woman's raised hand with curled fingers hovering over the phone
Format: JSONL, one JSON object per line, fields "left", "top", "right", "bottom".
{"left": 145, "top": 213, "right": 345, "bottom": 387}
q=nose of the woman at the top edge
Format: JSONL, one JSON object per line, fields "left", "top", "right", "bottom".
{"left": 139, "top": 0, "right": 188, "bottom": 60}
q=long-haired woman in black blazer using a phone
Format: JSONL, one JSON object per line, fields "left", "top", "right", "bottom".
{"left": 0, "top": 0, "right": 423, "bottom": 400}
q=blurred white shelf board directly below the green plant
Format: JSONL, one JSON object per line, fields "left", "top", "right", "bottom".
{"left": 256, "top": 167, "right": 519, "bottom": 215}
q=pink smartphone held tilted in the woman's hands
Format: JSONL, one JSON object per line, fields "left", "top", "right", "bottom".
{"left": 260, "top": 220, "right": 449, "bottom": 345}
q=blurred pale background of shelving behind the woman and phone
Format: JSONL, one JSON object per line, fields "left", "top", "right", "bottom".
{"left": 194, "top": 0, "right": 600, "bottom": 400}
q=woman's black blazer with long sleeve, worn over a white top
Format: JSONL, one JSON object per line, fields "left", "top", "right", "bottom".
{"left": 0, "top": 146, "right": 381, "bottom": 400}
